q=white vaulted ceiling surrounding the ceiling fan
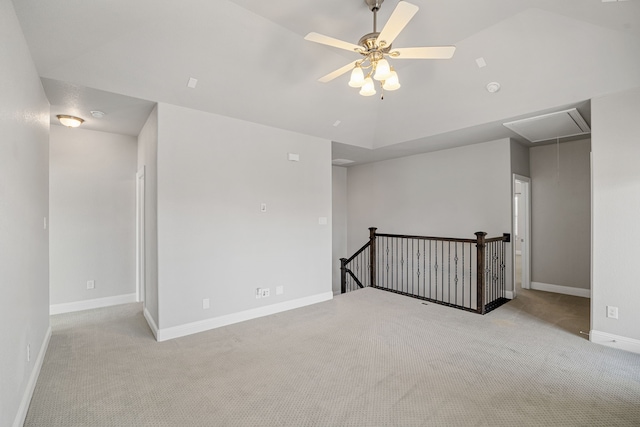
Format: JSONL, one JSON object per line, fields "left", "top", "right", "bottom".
{"left": 14, "top": 0, "right": 640, "bottom": 161}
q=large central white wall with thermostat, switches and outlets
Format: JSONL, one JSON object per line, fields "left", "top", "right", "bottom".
{"left": 158, "top": 104, "right": 332, "bottom": 330}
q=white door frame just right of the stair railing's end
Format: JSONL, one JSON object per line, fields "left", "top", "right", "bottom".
{"left": 511, "top": 173, "right": 531, "bottom": 297}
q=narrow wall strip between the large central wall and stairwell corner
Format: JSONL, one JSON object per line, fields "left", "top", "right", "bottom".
{"left": 331, "top": 166, "right": 350, "bottom": 294}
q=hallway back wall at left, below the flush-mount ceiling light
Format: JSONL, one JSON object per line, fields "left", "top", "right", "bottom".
{"left": 49, "top": 125, "right": 137, "bottom": 306}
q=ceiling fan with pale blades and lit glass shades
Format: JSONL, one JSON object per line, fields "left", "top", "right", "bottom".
{"left": 305, "top": 0, "right": 456, "bottom": 96}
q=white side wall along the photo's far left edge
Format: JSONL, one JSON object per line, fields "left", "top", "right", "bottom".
{"left": 0, "top": 0, "right": 50, "bottom": 426}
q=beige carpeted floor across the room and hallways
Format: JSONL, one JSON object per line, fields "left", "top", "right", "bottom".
{"left": 25, "top": 289, "right": 640, "bottom": 427}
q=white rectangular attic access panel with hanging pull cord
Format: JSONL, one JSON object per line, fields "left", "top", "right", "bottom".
{"left": 504, "top": 108, "right": 591, "bottom": 142}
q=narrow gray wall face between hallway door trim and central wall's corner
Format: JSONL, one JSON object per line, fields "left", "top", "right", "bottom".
{"left": 138, "top": 106, "right": 159, "bottom": 327}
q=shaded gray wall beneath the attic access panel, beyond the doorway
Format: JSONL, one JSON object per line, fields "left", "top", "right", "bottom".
{"left": 530, "top": 140, "right": 591, "bottom": 289}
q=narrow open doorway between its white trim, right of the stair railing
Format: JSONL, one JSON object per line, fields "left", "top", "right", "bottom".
{"left": 513, "top": 174, "right": 531, "bottom": 297}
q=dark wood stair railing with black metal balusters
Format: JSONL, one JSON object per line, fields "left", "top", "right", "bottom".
{"left": 340, "top": 227, "right": 511, "bottom": 314}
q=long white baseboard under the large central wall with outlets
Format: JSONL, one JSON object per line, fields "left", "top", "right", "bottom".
{"left": 157, "top": 291, "right": 333, "bottom": 342}
